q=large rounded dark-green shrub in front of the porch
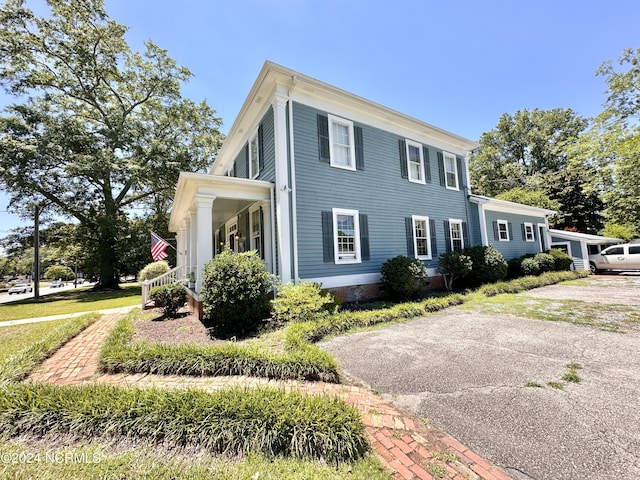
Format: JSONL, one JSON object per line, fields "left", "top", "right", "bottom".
{"left": 201, "top": 248, "right": 275, "bottom": 335}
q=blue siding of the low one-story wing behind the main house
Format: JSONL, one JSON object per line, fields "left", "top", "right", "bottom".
{"left": 485, "top": 210, "right": 544, "bottom": 260}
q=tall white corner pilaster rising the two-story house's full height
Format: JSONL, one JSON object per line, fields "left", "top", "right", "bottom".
{"left": 273, "top": 92, "right": 292, "bottom": 283}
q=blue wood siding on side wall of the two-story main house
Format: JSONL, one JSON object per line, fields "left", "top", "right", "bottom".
{"left": 293, "top": 103, "right": 471, "bottom": 278}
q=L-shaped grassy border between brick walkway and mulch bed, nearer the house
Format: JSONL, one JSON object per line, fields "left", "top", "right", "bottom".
{"left": 100, "top": 313, "right": 338, "bottom": 383}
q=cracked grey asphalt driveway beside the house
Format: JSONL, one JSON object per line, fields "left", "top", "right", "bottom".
{"left": 321, "top": 277, "right": 640, "bottom": 480}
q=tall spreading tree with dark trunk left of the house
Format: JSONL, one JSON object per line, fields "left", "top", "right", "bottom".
{"left": 0, "top": 0, "right": 222, "bottom": 288}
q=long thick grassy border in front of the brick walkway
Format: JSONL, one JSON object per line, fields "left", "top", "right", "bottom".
{"left": 0, "top": 384, "right": 368, "bottom": 462}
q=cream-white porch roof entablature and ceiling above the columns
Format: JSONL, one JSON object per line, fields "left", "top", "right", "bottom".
{"left": 169, "top": 172, "right": 273, "bottom": 232}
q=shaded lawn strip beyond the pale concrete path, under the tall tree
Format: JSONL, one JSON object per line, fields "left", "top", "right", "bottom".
{"left": 0, "top": 284, "right": 142, "bottom": 322}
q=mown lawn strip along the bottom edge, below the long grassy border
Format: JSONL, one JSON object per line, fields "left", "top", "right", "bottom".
{"left": 0, "top": 441, "right": 392, "bottom": 480}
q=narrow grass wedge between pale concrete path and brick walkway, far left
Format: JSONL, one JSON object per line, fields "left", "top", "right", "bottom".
{"left": 0, "top": 313, "right": 100, "bottom": 385}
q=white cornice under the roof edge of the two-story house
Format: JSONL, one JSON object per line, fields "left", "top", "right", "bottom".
{"left": 209, "top": 61, "right": 478, "bottom": 175}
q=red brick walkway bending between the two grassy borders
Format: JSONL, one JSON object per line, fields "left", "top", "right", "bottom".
{"left": 27, "top": 314, "right": 511, "bottom": 480}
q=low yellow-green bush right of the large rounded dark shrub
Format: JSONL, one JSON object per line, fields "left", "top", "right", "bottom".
{"left": 271, "top": 282, "right": 334, "bottom": 323}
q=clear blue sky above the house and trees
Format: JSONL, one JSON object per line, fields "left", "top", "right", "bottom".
{"left": 0, "top": 0, "right": 640, "bottom": 236}
